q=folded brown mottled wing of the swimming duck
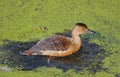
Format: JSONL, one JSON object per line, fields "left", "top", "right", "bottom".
{"left": 29, "top": 35, "right": 71, "bottom": 53}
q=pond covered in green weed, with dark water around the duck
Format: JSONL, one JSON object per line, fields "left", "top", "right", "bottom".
{"left": 0, "top": 0, "right": 120, "bottom": 77}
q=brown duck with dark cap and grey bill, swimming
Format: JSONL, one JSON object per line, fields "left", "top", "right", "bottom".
{"left": 23, "top": 23, "right": 93, "bottom": 57}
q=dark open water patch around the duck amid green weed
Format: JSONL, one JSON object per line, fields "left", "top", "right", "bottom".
{"left": 1, "top": 33, "right": 106, "bottom": 72}
